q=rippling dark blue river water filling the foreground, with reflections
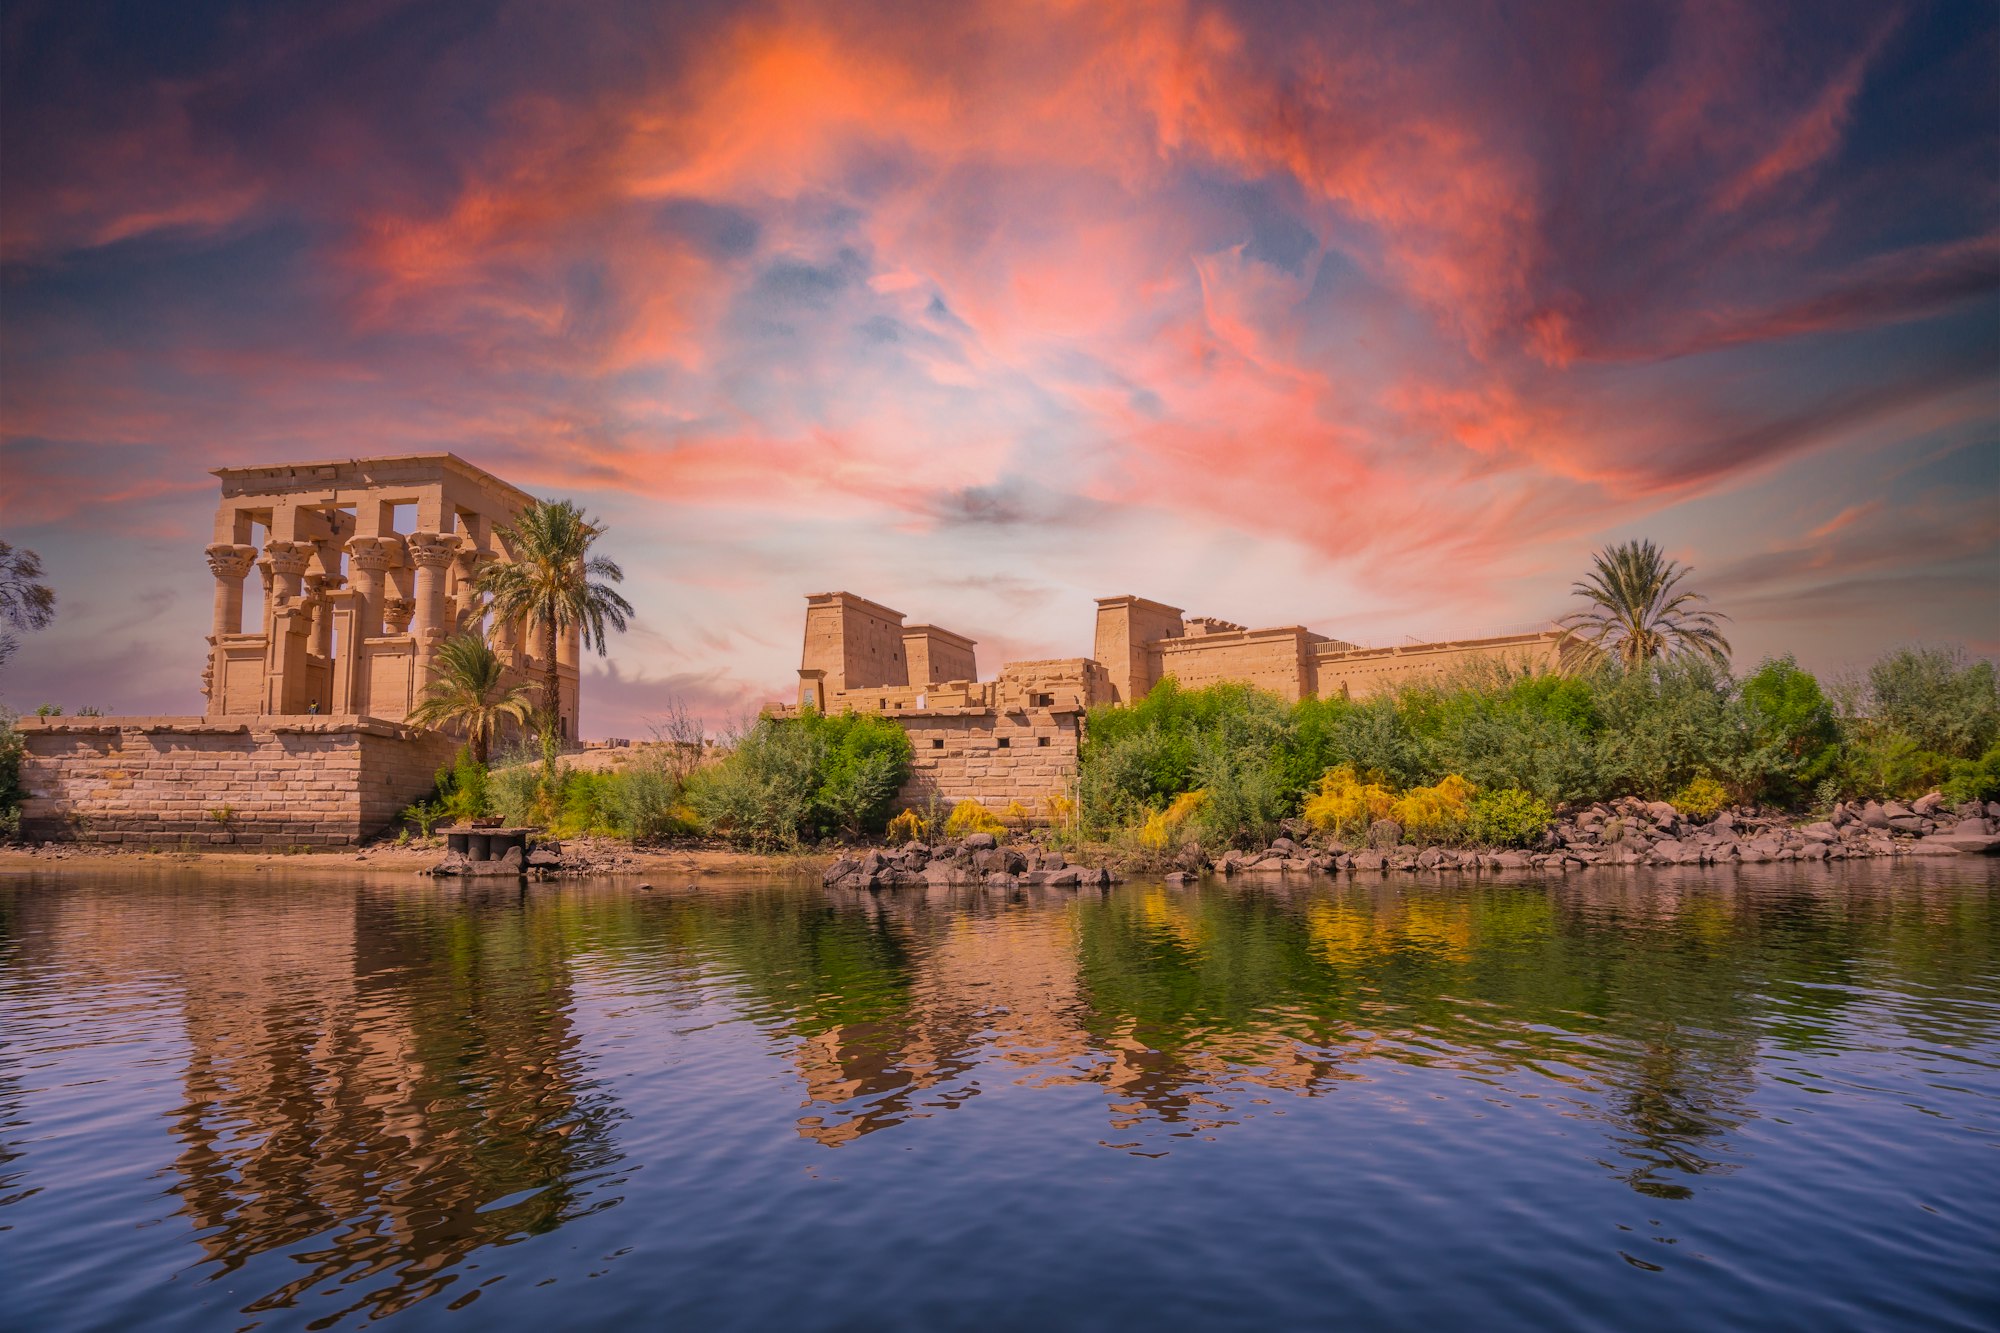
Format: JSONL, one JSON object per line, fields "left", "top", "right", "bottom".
{"left": 0, "top": 859, "right": 2000, "bottom": 1333}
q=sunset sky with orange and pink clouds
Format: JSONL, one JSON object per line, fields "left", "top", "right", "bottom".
{"left": 0, "top": 0, "right": 2000, "bottom": 737}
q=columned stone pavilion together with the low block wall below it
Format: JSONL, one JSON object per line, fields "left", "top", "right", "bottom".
{"left": 20, "top": 454, "right": 560, "bottom": 847}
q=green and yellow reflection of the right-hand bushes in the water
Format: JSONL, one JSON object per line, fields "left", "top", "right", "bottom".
{"left": 1074, "top": 872, "right": 1992, "bottom": 1195}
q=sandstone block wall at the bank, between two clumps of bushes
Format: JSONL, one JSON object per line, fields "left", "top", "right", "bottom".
{"left": 892, "top": 709, "right": 1082, "bottom": 821}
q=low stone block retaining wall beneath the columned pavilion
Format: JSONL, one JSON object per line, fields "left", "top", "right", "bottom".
{"left": 20, "top": 717, "right": 458, "bottom": 849}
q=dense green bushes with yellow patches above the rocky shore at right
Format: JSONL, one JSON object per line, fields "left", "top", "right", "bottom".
{"left": 1080, "top": 648, "right": 2000, "bottom": 847}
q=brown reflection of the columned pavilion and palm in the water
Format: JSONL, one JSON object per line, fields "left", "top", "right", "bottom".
{"left": 174, "top": 880, "right": 620, "bottom": 1315}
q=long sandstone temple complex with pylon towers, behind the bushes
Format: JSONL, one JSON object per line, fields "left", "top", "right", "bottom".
{"left": 778, "top": 592, "right": 1572, "bottom": 819}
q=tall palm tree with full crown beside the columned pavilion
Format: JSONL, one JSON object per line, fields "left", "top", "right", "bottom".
{"left": 478, "top": 500, "right": 632, "bottom": 733}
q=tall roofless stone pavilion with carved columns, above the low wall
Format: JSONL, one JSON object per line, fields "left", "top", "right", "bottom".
{"left": 202, "top": 454, "right": 580, "bottom": 739}
